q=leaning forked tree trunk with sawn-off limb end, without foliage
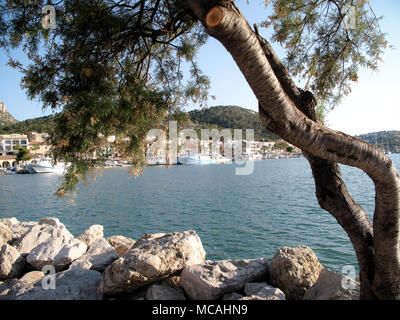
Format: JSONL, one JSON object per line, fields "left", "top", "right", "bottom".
{"left": 187, "top": 0, "right": 400, "bottom": 299}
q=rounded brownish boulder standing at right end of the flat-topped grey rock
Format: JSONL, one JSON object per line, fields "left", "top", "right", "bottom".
{"left": 269, "top": 246, "right": 322, "bottom": 300}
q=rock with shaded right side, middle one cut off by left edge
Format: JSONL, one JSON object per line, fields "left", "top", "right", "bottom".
{"left": 0, "top": 243, "right": 26, "bottom": 280}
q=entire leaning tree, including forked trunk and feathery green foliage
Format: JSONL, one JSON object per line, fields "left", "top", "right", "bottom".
{"left": 0, "top": 0, "right": 400, "bottom": 299}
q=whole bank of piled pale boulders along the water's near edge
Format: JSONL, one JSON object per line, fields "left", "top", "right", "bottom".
{"left": 0, "top": 217, "right": 359, "bottom": 300}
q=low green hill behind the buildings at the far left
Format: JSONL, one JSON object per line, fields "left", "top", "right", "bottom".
{"left": 0, "top": 115, "right": 56, "bottom": 134}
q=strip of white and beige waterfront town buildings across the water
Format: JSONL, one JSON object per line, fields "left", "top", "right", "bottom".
{"left": 0, "top": 132, "right": 301, "bottom": 174}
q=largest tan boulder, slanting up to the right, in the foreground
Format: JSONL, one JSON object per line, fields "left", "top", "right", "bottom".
{"left": 99, "top": 230, "right": 206, "bottom": 295}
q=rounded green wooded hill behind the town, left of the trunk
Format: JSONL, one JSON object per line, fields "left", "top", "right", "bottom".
{"left": 189, "top": 106, "right": 279, "bottom": 141}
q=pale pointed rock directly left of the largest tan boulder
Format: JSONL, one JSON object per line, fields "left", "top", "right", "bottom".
{"left": 76, "top": 238, "right": 119, "bottom": 272}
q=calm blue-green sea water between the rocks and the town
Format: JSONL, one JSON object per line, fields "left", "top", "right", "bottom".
{"left": 0, "top": 154, "right": 400, "bottom": 271}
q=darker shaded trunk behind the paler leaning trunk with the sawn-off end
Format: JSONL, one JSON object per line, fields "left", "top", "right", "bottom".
{"left": 255, "top": 31, "right": 376, "bottom": 300}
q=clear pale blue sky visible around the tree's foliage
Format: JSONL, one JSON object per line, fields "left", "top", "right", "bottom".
{"left": 0, "top": 0, "right": 400, "bottom": 134}
